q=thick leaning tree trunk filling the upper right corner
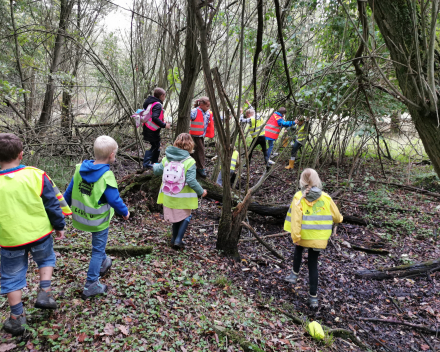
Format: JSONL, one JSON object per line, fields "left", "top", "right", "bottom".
{"left": 368, "top": 0, "right": 440, "bottom": 176}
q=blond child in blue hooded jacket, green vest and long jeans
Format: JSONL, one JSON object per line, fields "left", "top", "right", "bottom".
{"left": 64, "top": 136, "right": 130, "bottom": 299}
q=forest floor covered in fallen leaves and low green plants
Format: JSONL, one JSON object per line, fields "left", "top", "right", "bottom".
{"left": 0, "top": 144, "right": 440, "bottom": 352}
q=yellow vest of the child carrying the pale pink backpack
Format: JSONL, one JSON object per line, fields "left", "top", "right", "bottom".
{"left": 157, "top": 157, "right": 199, "bottom": 209}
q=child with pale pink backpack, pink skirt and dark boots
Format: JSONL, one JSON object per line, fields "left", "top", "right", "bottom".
{"left": 153, "top": 133, "right": 208, "bottom": 249}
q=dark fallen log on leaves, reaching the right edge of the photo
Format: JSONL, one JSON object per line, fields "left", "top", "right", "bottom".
{"left": 355, "top": 258, "right": 440, "bottom": 280}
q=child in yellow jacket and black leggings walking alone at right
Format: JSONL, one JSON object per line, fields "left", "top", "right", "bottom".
{"left": 284, "top": 169, "right": 343, "bottom": 308}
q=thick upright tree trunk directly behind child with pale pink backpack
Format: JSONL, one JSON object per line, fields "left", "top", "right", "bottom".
{"left": 176, "top": 4, "right": 200, "bottom": 136}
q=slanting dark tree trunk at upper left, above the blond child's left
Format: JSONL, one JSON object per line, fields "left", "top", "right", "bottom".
{"left": 38, "top": 0, "right": 74, "bottom": 127}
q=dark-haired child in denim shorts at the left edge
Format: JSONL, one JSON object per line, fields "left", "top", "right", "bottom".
{"left": 0, "top": 133, "right": 70, "bottom": 335}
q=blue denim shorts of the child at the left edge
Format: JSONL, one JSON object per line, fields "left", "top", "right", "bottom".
{"left": 0, "top": 235, "right": 56, "bottom": 295}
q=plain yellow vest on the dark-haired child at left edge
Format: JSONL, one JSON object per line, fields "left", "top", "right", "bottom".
{"left": 0, "top": 166, "right": 53, "bottom": 247}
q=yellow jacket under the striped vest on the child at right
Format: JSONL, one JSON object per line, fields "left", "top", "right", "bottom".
{"left": 291, "top": 191, "right": 343, "bottom": 249}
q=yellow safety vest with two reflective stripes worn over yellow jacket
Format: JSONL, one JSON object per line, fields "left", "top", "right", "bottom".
{"left": 301, "top": 197, "right": 333, "bottom": 240}
